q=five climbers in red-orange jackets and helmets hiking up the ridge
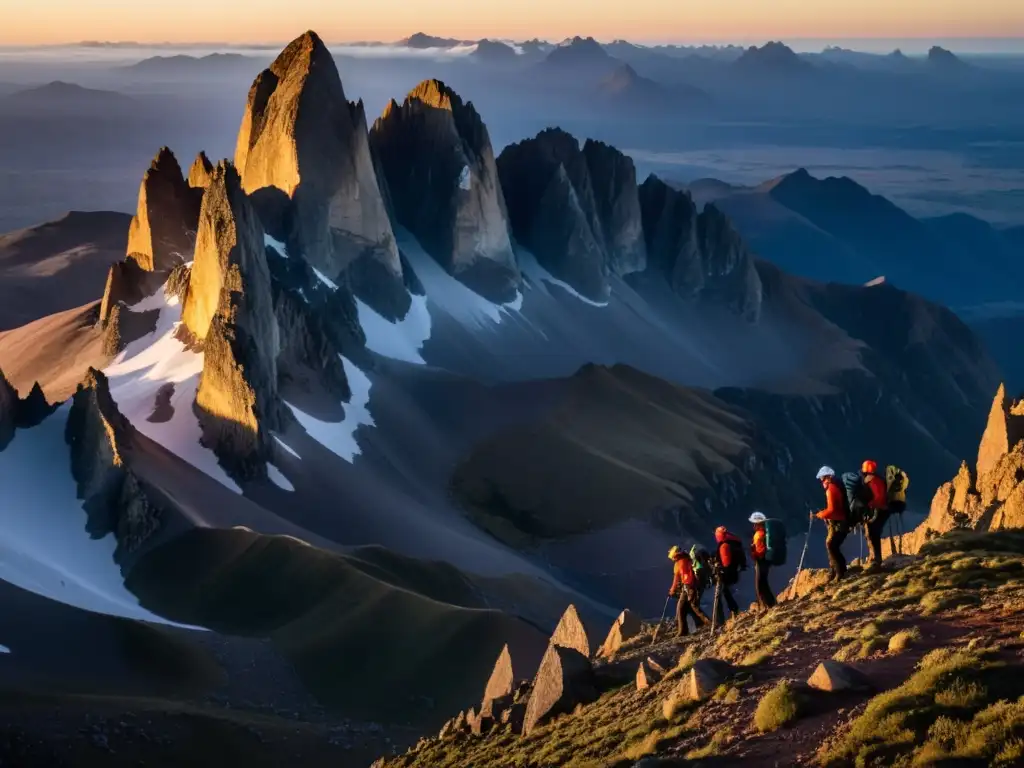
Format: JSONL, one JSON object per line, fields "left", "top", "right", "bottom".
{"left": 666, "top": 460, "right": 909, "bottom": 636}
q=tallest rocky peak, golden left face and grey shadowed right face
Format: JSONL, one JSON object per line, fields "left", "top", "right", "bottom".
{"left": 234, "top": 32, "right": 410, "bottom": 316}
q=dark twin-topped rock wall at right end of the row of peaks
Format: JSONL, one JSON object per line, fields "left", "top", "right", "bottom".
{"left": 640, "top": 175, "right": 763, "bottom": 322}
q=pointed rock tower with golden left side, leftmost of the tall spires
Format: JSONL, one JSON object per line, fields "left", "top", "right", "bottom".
{"left": 128, "top": 146, "right": 202, "bottom": 272}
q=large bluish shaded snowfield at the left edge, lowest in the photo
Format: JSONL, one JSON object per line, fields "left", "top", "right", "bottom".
{"left": 0, "top": 403, "right": 178, "bottom": 624}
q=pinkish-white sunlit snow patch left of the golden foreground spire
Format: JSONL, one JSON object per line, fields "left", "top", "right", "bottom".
{"left": 103, "top": 290, "right": 242, "bottom": 494}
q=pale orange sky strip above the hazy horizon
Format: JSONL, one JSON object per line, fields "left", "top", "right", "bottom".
{"left": 0, "top": 0, "right": 1024, "bottom": 44}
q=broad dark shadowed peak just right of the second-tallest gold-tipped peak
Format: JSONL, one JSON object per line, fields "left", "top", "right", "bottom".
{"left": 498, "top": 128, "right": 608, "bottom": 301}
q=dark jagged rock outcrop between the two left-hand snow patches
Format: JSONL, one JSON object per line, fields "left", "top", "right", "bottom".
{"left": 65, "top": 369, "right": 164, "bottom": 562}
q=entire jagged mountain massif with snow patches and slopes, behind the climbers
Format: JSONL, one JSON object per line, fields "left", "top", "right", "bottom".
{"left": 0, "top": 32, "right": 999, "bottom": 765}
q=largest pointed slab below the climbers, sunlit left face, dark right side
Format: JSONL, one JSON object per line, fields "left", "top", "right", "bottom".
{"left": 522, "top": 644, "right": 597, "bottom": 734}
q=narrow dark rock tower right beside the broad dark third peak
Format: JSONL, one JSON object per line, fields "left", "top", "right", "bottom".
{"left": 583, "top": 139, "right": 647, "bottom": 274}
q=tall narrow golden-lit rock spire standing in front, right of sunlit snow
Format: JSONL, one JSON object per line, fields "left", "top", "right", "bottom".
{"left": 181, "top": 161, "right": 281, "bottom": 476}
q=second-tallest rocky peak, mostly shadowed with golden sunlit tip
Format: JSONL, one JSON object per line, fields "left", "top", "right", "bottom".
{"left": 370, "top": 80, "right": 519, "bottom": 302}
